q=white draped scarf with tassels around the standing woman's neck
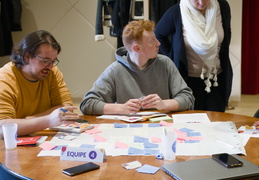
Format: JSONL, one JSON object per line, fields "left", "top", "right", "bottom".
{"left": 180, "top": 0, "right": 218, "bottom": 93}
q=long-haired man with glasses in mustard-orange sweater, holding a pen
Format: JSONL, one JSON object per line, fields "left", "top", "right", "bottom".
{"left": 0, "top": 30, "right": 78, "bottom": 135}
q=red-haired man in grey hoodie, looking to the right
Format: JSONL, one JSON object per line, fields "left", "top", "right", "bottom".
{"left": 80, "top": 20, "right": 194, "bottom": 115}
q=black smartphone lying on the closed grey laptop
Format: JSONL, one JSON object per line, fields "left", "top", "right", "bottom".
{"left": 212, "top": 153, "right": 243, "bottom": 168}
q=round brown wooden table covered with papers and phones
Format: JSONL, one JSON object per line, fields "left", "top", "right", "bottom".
{"left": 0, "top": 111, "right": 259, "bottom": 180}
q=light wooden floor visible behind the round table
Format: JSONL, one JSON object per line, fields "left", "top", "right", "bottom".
{"left": 73, "top": 94, "right": 259, "bottom": 116}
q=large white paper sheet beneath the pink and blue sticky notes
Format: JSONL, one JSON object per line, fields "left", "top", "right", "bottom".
{"left": 39, "top": 122, "right": 246, "bottom": 156}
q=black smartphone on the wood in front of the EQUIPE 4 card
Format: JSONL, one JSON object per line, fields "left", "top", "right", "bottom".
{"left": 62, "top": 162, "right": 100, "bottom": 176}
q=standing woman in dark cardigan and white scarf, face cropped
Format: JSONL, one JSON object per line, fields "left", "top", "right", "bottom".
{"left": 155, "top": 0, "right": 233, "bottom": 112}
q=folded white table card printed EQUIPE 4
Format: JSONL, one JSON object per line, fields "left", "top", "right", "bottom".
{"left": 60, "top": 146, "right": 106, "bottom": 162}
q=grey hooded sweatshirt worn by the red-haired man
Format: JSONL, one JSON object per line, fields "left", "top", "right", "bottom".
{"left": 80, "top": 47, "right": 194, "bottom": 115}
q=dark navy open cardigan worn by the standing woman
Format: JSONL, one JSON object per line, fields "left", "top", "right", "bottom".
{"left": 155, "top": 0, "right": 233, "bottom": 105}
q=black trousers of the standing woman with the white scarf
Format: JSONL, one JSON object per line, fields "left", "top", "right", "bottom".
{"left": 187, "top": 74, "right": 226, "bottom": 112}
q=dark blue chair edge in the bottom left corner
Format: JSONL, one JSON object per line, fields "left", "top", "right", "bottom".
{"left": 0, "top": 162, "right": 33, "bottom": 180}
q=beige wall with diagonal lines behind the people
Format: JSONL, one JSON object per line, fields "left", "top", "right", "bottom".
{"left": 0, "top": 0, "right": 242, "bottom": 105}
